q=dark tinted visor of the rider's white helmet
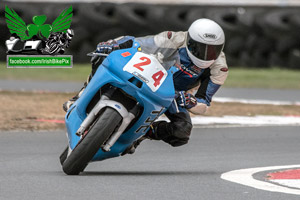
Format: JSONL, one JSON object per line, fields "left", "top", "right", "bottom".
{"left": 187, "top": 34, "right": 223, "bottom": 61}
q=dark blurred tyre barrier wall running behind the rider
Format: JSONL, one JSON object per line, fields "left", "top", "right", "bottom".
{"left": 0, "top": 2, "right": 300, "bottom": 69}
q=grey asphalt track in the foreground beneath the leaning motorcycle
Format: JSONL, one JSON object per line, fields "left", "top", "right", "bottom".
{"left": 0, "top": 126, "right": 300, "bottom": 200}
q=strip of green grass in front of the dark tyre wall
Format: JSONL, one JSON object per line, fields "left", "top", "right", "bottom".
{"left": 0, "top": 63, "right": 300, "bottom": 89}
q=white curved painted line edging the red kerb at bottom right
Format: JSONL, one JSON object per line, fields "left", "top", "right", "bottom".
{"left": 221, "top": 165, "right": 300, "bottom": 195}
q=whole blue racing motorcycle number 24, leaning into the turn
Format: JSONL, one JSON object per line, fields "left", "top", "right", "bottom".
{"left": 60, "top": 41, "right": 177, "bottom": 175}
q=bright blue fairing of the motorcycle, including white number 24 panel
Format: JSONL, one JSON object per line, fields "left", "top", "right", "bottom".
{"left": 65, "top": 42, "right": 177, "bottom": 161}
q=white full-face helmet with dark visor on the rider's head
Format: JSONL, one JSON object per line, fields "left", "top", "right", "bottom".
{"left": 186, "top": 18, "right": 225, "bottom": 69}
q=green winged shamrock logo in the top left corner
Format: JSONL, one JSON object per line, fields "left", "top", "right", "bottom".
{"left": 5, "top": 6, "right": 73, "bottom": 40}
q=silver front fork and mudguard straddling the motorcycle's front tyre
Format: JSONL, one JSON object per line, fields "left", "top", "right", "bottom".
{"left": 76, "top": 87, "right": 139, "bottom": 152}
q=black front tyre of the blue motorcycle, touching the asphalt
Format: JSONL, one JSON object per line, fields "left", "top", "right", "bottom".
{"left": 63, "top": 107, "right": 122, "bottom": 175}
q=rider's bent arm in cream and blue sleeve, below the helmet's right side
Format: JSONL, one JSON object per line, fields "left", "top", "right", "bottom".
{"left": 189, "top": 53, "right": 228, "bottom": 115}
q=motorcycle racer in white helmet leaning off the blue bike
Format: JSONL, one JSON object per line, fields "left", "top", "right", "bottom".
{"left": 63, "top": 18, "right": 228, "bottom": 152}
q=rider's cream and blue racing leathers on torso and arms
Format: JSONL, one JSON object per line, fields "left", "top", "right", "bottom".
{"left": 133, "top": 31, "right": 228, "bottom": 115}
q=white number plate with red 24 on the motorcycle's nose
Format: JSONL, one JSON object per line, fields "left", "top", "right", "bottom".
{"left": 123, "top": 52, "right": 168, "bottom": 92}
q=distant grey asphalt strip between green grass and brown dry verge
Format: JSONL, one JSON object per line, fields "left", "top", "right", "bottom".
{"left": 0, "top": 80, "right": 300, "bottom": 102}
